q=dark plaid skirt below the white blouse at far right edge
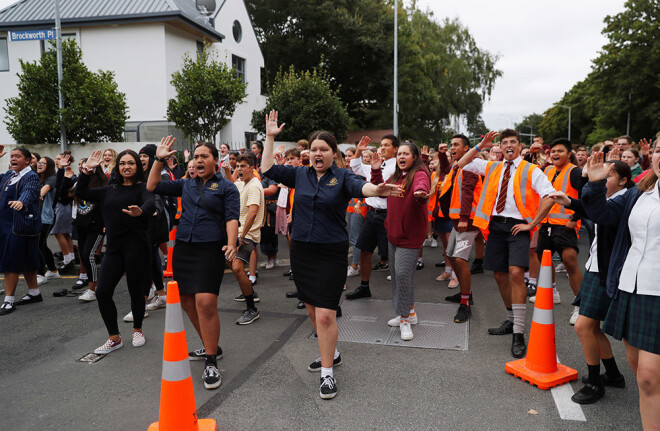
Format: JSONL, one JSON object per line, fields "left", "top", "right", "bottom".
{"left": 603, "top": 290, "right": 660, "bottom": 355}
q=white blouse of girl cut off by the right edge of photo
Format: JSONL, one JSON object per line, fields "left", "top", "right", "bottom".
{"left": 619, "top": 181, "right": 660, "bottom": 296}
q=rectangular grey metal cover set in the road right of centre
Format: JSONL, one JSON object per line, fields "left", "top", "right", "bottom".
{"left": 337, "top": 299, "right": 469, "bottom": 350}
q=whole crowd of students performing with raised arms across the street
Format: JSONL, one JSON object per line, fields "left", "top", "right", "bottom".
{"left": 0, "top": 115, "right": 660, "bottom": 429}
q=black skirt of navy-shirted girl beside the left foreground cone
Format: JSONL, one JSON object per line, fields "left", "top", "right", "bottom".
{"left": 172, "top": 240, "right": 225, "bottom": 295}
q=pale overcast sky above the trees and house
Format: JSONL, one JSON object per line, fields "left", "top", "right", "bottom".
{"left": 0, "top": 0, "right": 624, "bottom": 130}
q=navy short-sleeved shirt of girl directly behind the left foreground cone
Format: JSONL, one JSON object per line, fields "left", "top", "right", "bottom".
{"left": 154, "top": 172, "right": 241, "bottom": 244}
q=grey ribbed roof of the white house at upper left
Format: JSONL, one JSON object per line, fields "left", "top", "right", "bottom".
{"left": 0, "top": 0, "right": 224, "bottom": 42}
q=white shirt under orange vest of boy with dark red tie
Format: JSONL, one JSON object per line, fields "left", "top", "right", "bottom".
{"left": 463, "top": 156, "right": 555, "bottom": 220}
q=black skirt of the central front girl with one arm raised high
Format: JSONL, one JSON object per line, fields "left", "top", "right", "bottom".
{"left": 291, "top": 240, "right": 348, "bottom": 310}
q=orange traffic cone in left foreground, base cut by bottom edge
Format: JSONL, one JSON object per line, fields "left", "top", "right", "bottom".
{"left": 149, "top": 281, "right": 218, "bottom": 431}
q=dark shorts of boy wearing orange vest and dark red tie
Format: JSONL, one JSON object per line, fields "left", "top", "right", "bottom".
{"left": 484, "top": 219, "right": 530, "bottom": 272}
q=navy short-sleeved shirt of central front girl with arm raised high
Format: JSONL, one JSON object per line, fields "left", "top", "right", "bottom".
{"left": 264, "top": 163, "right": 366, "bottom": 243}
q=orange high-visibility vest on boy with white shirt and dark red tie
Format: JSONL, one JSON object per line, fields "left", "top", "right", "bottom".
{"left": 473, "top": 160, "right": 541, "bottom": 232}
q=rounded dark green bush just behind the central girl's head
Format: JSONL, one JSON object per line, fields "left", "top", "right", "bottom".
{"left": 252, "top": 66, "right": 348, "bottom": 142}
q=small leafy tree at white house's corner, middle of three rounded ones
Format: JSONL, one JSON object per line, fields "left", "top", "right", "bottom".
{"left": 167, "top": 45, "right": 246, "bottom": 142}
